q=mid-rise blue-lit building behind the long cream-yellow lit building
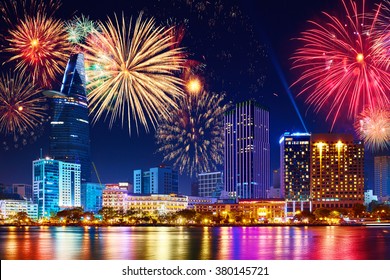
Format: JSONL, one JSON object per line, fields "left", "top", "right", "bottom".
{"left": 133, "top": 166, "right": 179, "bottom": 194}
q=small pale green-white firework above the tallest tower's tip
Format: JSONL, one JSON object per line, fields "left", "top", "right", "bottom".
{"left": 65, "top": 15, "right": 98, "bottom": 44}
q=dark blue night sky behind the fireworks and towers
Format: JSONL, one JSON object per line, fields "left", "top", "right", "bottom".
{"left": 0, "top": 0, "right": 384, "bottom": 193}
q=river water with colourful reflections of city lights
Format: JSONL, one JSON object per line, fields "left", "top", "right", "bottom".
{"left": 0, "top": 226, "right": 390, "bottom": 260}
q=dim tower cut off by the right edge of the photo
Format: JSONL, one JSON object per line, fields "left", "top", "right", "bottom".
{"left": 374, "top": 156, "right": 390, "bottom": 202}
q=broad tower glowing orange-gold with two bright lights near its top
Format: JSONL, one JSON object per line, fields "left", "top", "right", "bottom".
{"left": 310, "top": 134, "right": 364, "bottom": 208}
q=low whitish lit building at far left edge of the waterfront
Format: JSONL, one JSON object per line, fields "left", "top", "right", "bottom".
{"left": 0, "top": 199, "right": 38, "bottom": 220}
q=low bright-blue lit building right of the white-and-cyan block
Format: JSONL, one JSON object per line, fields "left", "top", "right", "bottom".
{"left": 81, "top": 183, "right": 105, "bottom": 213}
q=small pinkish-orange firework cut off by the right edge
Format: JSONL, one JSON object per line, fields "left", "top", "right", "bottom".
{"left": 355, "top": 107, "right": 390, "bottom": 150}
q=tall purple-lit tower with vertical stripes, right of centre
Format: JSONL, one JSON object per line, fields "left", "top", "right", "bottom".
{"left": 224, "top": 100, "right": 271, "bottom": 198}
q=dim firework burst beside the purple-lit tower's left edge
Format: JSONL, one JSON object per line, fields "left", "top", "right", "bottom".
{"left": 156, "top": 88, "right": 227, "bottom": 175}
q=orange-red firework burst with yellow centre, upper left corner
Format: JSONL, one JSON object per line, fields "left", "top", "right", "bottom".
{"left": 5, "top": 13, "right": 70, "bottom": 87}
